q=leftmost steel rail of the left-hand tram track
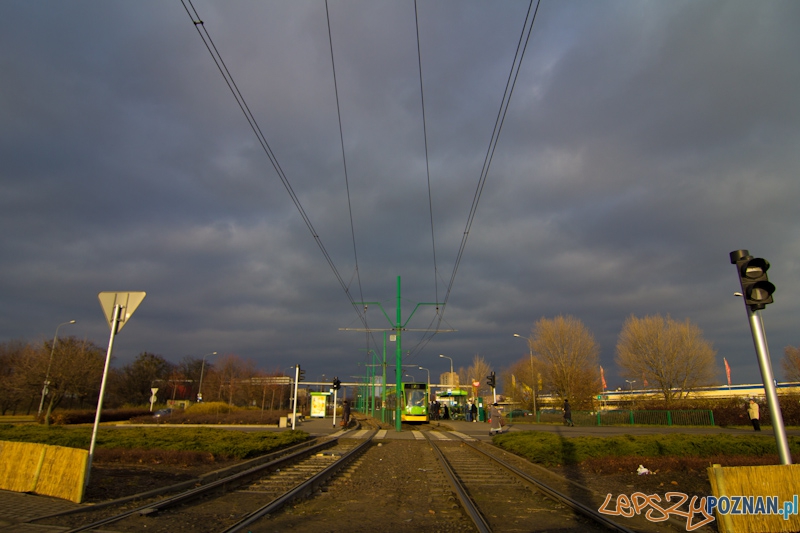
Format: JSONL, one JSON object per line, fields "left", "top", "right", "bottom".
{"left": 65, "top": 438, "right": 338, "bottom": 533}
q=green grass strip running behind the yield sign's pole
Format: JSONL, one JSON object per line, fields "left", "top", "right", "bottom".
{"left": 0, "top": 424, "right": 308, "bottom": 459}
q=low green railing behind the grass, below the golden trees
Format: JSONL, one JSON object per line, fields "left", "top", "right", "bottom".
{"left": 515, "top": 410, "right": 714, "bottom": 426}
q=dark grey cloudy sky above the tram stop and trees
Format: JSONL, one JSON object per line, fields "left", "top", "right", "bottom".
{"left": 0, "top": 0, "right": 800, "bottom": 387}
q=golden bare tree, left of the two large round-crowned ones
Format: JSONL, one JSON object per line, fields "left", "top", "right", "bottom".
{"left": 531, "top": 316, "right": 600, "bottom": 407}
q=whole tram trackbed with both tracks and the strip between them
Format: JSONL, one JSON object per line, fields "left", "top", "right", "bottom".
{"left": 25, "top": 422, "right": 692, "bottom": 533}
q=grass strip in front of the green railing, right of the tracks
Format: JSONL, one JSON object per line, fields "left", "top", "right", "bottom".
{"left": 493, "top": 431, "right": 800, "bottom": 465}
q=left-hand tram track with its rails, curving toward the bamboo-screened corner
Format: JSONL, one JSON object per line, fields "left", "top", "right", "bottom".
{"left": 33, "top": 432, "right": 375, "bottom": 533}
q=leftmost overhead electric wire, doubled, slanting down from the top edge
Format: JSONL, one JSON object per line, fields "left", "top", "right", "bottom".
{"left": 180, "top": 0, "right": 366, "bottom": 327}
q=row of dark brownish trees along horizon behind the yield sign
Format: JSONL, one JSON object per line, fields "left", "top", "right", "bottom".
{"left": 0, "top": 336, "right": 291, "bottom": 421}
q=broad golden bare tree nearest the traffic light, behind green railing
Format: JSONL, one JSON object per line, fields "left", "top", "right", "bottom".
{"left": 616, "top": 315, "right": 717, "bottom": 405}
